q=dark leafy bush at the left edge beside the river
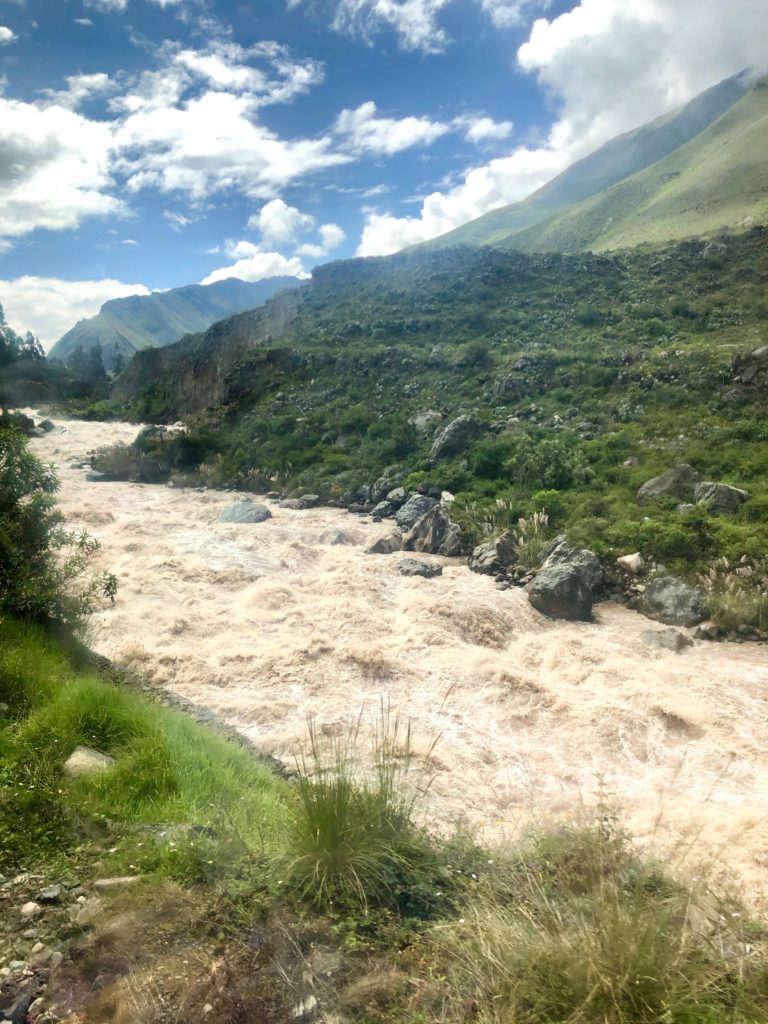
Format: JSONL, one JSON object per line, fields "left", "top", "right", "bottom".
{"left": 0, "top": 421, "right": 118, "bottom": 627}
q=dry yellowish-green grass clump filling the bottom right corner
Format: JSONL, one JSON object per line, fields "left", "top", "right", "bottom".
{"left": 443, "top": 813, "right": 768, "bottom": 1024}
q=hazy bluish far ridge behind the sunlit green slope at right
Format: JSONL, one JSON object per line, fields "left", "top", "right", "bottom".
{"left": 423, "top": 75, "right": 750, "bottom": 249}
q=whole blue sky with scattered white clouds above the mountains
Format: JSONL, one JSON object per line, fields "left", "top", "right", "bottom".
{"left": 0, "top": 0, "right": 768, "bottom": 345}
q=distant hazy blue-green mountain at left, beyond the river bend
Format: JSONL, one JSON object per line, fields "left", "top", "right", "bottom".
{"left": 48, "top": 278, "right": 298, "bottom": 369}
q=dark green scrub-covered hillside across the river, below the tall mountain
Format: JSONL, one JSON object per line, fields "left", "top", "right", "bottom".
{"left": 105, "top": 227, "right": 768, "bottom": 574}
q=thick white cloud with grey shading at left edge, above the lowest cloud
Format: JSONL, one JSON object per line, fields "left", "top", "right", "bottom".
{"left": 0, "top": 97, "right": 124, "bottom": 237}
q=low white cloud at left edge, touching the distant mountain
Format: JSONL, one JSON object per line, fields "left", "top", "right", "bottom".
{"left": 0, "top": 276, "right": 150, "bottom": 348}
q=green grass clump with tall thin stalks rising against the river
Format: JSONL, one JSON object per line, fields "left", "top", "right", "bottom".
{"left": 286, "top": 705, "right": 438, "bottom": 909}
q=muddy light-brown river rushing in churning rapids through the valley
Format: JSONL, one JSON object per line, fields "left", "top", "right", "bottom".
{"left": 27, "top": 421, "right": 768, "bottom": 904}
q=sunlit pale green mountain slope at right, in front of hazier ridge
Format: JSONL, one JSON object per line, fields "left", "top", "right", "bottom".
{"left": 512, "top": 78, "right": 768, "bottom": 252}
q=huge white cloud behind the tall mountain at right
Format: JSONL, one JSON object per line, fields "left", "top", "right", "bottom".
{"left": 357, "top": 0, "right": 768, "bottom": 256}
